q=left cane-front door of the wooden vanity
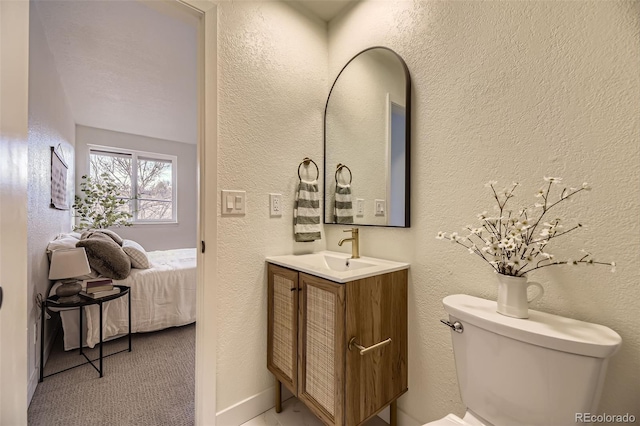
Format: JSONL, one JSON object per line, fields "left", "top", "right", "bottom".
{"left": 267, "top": 264, "right": 298, "bottom": 395}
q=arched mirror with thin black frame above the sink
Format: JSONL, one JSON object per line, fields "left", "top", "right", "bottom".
{"left": 324, "top": 47, "right": 411, "bottom": 227}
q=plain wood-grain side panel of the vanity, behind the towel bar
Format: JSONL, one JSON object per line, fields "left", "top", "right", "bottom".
{"left": 345, "top": 270, "right": 407, "bottom": 426}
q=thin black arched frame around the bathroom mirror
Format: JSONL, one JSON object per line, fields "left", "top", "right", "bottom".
{"left": 322, "top": 46, "right": 411, "bottom": 228}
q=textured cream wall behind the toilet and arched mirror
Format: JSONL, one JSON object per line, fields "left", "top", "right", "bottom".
{"left": 325, "top": 1, "right": 640, "bottom": 422}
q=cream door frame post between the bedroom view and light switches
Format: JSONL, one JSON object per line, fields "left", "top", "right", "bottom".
{"left": 177, "top": 0, "right": 218, "bottom": 426}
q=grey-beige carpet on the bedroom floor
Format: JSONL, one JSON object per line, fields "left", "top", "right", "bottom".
{"left": 28, "top": 324, "right": 195, "bottom": 426}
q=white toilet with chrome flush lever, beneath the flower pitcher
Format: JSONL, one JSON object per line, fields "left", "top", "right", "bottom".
{"left": 425, "top": 294, "right": 622, "bottom": 426}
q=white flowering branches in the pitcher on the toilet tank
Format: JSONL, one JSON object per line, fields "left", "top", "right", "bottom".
{"left": 436, "top": 177, "right": 616, "bottom": 277}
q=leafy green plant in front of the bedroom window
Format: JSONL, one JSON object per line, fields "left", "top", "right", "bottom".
{"left": 73, "top": 173, "right": 133, "bottom": 231}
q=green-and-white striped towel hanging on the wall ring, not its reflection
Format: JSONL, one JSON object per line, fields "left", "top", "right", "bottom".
{"left": 293, "top": 180, "right": 321, "bottom": 242}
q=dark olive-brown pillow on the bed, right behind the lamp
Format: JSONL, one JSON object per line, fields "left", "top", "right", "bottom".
{"left": 76, "top": 235, "right": 131, "bottom": 280}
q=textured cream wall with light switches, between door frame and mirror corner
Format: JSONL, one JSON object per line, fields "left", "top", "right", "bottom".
{"left": 212, "top": 1, "right": 328, "bottom": 411}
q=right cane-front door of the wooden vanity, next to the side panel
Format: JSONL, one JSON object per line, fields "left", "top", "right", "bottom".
{"left": 298, "top": 273, "right": 345, "bottom": 426}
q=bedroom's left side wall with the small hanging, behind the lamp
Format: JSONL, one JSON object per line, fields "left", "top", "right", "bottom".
{"left": 27, "top": 4, "right": 75, "bottom": 399}
